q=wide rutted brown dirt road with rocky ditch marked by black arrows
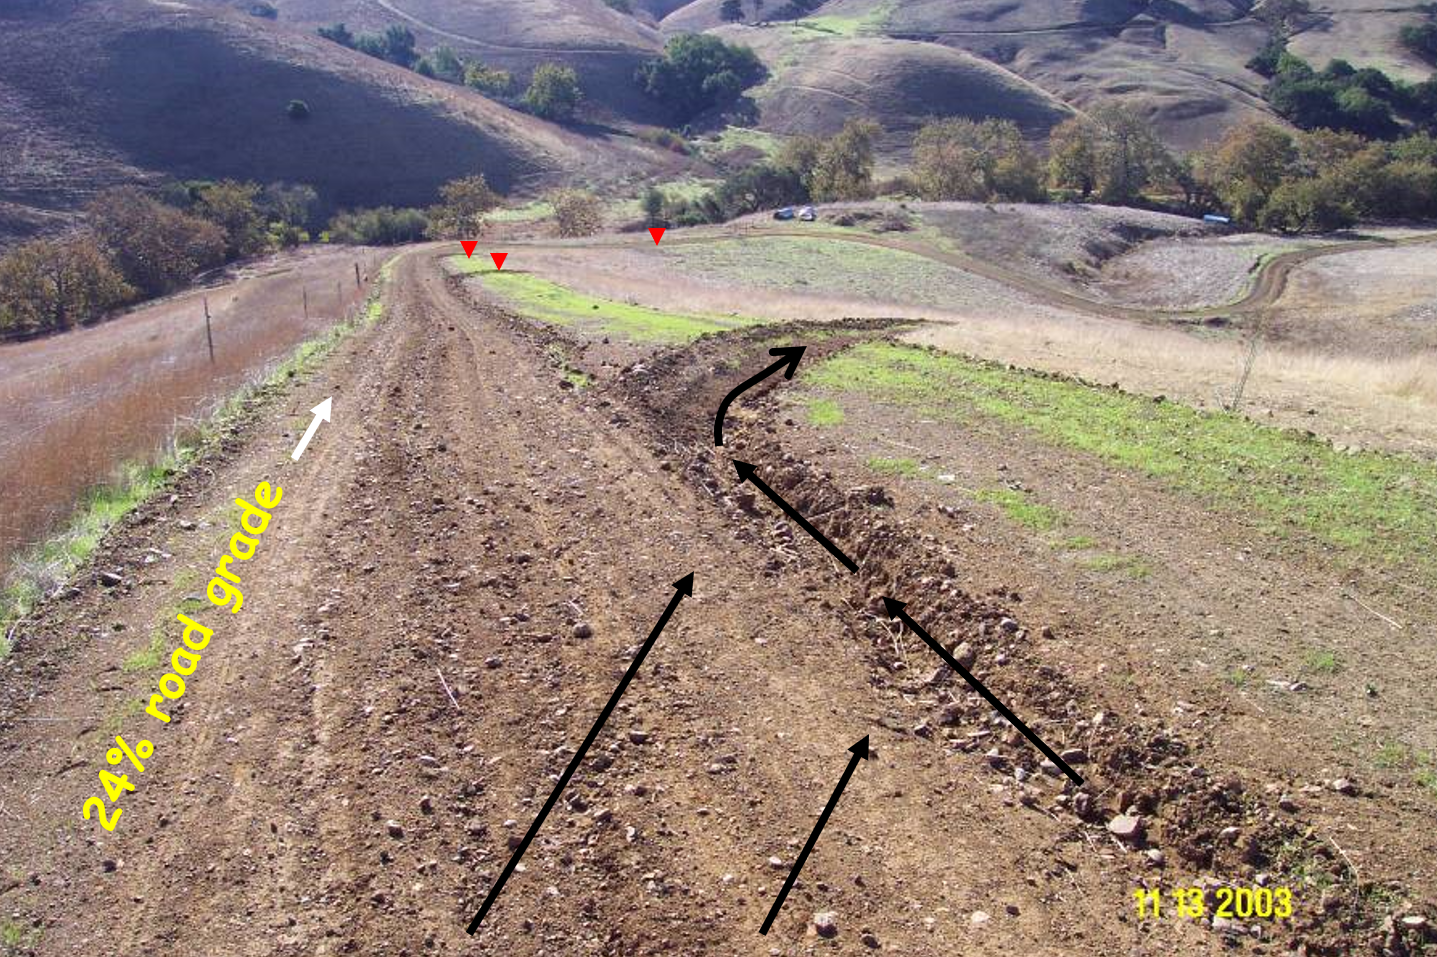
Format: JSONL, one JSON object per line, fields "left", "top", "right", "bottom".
{"left": 0, "top": 250, "right": 1437, "bottom": 957}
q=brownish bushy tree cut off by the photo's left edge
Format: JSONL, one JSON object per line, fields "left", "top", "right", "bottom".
{"left": 0, "top": 234, "right": 135, "bottom": 335}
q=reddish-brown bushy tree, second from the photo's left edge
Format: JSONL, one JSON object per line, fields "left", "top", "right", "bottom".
{"left": 85, "top": 187, "right": 224, "bottom": 296}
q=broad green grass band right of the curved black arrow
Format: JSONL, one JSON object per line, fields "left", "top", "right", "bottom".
{"left": 805, "top": 342, "right": 1437, "bottom": 576}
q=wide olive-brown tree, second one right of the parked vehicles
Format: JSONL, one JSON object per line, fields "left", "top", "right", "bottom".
{"left": 912, "top": 119, "right": 1045, "bottom": 203}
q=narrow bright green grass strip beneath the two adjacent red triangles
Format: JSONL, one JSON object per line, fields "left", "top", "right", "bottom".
{"left": 453, "top": 257, "right": 762, "bottom": 345}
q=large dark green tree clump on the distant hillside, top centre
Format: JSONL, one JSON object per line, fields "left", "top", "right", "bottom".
{"left": 635, "top": 33, "right": 763, "bottom": 124}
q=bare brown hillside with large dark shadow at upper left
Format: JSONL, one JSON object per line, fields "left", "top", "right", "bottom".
{"left": 0, "top": 0, "right": 677, "bottom": 240}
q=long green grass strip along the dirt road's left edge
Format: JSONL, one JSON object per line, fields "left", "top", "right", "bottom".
{"left": 0, "top": 257, "right": 398, "bottom": 658}
